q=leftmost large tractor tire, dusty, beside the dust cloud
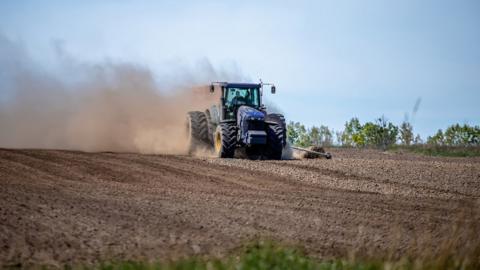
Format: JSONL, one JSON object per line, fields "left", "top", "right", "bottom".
{"left": 187, "top": 111, "right": 208, "bottom": 154}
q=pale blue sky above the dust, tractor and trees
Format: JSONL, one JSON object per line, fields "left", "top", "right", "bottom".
{"left": 0, "top": 0, "right": 480, "bottom": 137}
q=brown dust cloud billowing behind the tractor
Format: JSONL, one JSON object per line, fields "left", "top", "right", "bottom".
{"left": 0, "top": 35, "right": 238, "bottom": 154}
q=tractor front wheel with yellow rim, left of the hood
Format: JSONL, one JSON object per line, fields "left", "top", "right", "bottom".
{"left": 214, "top": 123, "right": 237, "bottom": 158}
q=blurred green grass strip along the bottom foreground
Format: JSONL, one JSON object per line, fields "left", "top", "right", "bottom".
{"left": 82, "top": 238, "right": 480, "bottom": 270}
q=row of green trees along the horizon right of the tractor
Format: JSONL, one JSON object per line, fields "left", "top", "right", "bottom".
{"left": 287, "top": 116, "right": 480, "bottom": 150}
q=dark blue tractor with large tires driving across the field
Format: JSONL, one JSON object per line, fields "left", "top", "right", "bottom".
{"left": 187, "top": 82, "right": 287, "bottom": 159}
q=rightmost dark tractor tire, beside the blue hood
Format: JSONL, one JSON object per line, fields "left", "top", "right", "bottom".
{"left": 265, "top": 114, "right": 287, "bottom": 160}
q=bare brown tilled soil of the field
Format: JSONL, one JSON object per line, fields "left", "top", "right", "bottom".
{"left": 0, "top": 149, "right": 480, "bottom": 266}
